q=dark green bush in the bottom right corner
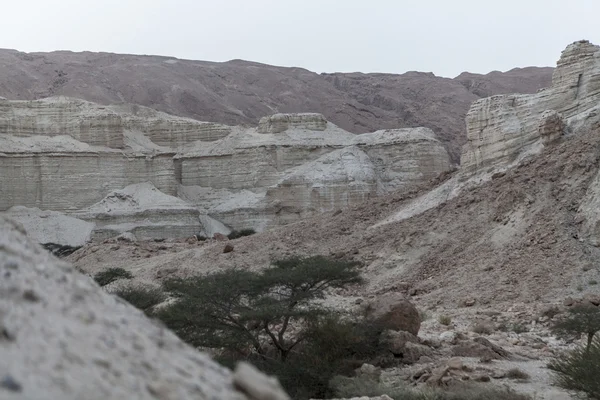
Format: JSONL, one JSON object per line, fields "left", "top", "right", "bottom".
{"left": 548, "top": 339, "right": 600, "bottom": 399}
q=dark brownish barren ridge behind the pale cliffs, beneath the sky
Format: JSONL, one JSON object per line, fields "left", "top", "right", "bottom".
{"left": 0, "top": 50, "right": 552, "bottom": 162}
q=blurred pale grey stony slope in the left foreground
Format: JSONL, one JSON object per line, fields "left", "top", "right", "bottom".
{"left": 0, "top": 217, "right": 287, "bottom": 400}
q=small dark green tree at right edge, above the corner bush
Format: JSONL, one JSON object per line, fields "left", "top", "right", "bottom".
{"left": 552, "top": 304, "right": 600, "bottom": 351}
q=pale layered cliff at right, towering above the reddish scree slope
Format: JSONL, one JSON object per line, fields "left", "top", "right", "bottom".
{"left": 461, "top": 41, "right": 600, "bottom": 175}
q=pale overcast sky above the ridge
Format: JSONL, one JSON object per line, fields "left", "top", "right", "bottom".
{"left": 0, "top": 0, "right": 600, "bottom": 77}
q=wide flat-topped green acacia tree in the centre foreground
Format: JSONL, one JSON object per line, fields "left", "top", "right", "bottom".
{"left": 157, "top": 256, "right": 362, "bottom": 361}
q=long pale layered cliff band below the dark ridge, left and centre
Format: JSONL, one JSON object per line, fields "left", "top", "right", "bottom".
{"left": 0, "top": 98, "right": 452, "bottom": 244}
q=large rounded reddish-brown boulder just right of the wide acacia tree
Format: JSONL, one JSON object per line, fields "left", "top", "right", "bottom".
{"left": 366, "top": 293, "right": 421, "bottom": 336}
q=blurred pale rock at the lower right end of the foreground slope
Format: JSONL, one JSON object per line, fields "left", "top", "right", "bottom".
{"left": 233, "top": 362, "right": 290, "bottom": 400}
